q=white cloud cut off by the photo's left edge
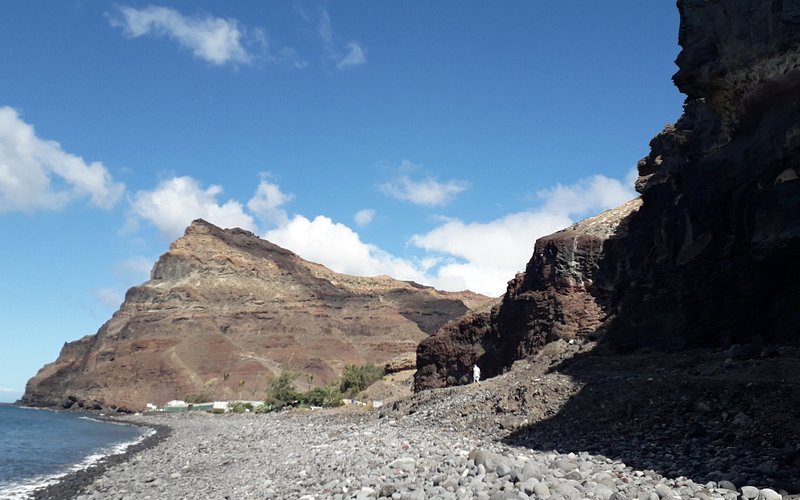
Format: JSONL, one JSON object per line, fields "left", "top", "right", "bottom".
{"left": 0, "top": 106, "right": 125, "bottom": 213}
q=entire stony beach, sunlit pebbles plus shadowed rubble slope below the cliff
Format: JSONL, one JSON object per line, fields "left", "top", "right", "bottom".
{"left": 28, "top": 346, "right": 800, "bottom": 500}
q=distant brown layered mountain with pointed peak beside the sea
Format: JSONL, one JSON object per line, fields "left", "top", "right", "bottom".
{"left": 22, "top": 220, "right": 487, "bottom": 410}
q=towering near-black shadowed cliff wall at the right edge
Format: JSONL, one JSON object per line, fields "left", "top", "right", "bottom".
{"left": 602, "top": 0, "right": 800, "bottom": 349}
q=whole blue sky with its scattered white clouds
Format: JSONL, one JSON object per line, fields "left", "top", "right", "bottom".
{"left": 0, "top": 0, "right": 683, "bottom": 401}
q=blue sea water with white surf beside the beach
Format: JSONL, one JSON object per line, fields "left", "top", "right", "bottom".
{"left": 0, "top": 404, "right": 152, "bottom": 499}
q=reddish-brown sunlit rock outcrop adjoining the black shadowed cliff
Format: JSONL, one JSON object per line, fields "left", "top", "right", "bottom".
{"left": 414, "top": 198, "right": 641, "bottom": 391}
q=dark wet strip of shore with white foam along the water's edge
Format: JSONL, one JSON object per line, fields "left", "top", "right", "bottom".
{"left": 28, "top": 408, "right": 172, "bottom": 500}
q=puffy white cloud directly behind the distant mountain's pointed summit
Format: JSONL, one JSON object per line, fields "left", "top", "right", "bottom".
{"left": 131, "top": 176, "right": 256, "bottom": 238}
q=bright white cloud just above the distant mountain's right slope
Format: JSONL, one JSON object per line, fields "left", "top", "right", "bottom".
{"left": 264, "top": 215, "right": 426, "bottom": 282}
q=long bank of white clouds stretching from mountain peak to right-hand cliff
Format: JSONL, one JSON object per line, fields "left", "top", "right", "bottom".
{"left": 128, "top": 175, "right": 636, "bottom": 296}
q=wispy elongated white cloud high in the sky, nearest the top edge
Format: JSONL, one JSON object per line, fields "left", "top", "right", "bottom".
{"left": 110, "top": 5, "right": 266, "bottom": 66}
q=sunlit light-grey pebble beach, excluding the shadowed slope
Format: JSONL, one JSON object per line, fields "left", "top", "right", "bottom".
{"left": 29, "top": 411, "right": 780, "bottom": 500}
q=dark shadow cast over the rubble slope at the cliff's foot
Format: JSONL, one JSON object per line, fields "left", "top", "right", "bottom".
{"left": 504, "top": 350, "right": 800, "bottom": 493}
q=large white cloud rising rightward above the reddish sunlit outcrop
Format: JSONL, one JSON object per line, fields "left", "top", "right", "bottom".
{"left": 411, "top": 175, "right": 636, "bottom": 295}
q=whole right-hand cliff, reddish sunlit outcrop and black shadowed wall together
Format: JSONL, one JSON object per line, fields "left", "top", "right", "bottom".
{"left": 415, "top": 0, "right": 800, "bottom": 390}
